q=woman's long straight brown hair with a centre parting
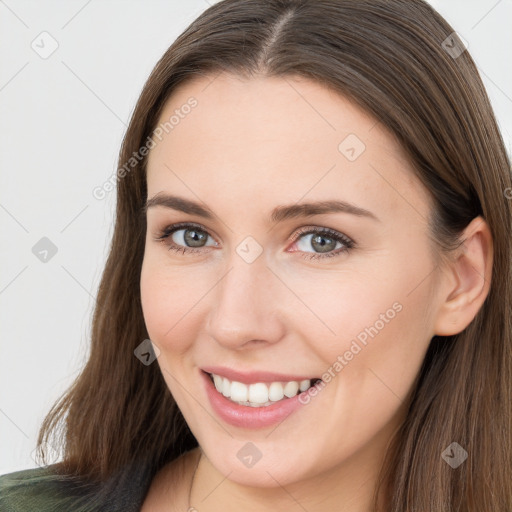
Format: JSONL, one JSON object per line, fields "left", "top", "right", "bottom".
{"left": 38, "top": 0, "right": 512, "bottom": 512}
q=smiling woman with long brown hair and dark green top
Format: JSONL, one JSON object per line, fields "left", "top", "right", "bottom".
{"left": 0, "top": 0, "right": 512, "bottom": 512}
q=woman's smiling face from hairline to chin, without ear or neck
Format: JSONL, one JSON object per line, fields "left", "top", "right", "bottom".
{"left": 141, "top": 74, "right": 439, "bottom": 487}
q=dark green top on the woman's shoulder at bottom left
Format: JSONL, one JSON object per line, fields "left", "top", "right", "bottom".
{"left": 0, "top": 464, "right": 153, "bottom": 512}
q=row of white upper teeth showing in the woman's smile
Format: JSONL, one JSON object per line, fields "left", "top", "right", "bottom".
{"left": 212, "top": 374, "right": 311, "bottom": 405}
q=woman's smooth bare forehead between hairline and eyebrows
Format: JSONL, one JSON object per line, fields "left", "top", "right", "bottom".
{"left": 148, "top": 73, "right": 430, "bottom": 222}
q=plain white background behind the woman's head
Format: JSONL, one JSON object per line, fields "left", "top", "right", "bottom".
{"left": 0, "top": 0, "right": 512, "bottom": 474}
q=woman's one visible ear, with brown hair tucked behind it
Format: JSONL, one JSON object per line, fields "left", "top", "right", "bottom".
{"left": 434, "top": 216, "right": 493, "bottom": 336}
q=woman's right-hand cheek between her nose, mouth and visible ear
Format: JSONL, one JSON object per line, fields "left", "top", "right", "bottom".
{"left": 291, "top": 249, "right": 433, "bottom": 392}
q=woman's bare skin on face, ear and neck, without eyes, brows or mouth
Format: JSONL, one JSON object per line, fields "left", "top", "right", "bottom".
{"left": 141, "top": 74, "right": 492, "bottom": 512}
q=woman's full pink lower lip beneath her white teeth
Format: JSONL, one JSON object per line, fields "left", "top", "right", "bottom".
{"left": 199, "top": 370, "right": 316, "bottom": 429}
